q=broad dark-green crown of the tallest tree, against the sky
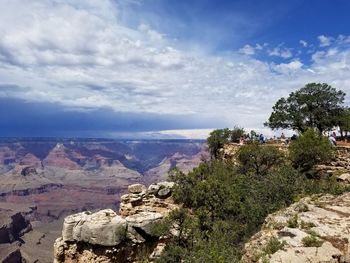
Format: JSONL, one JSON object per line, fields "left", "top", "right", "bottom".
{"left": 265, "top": 83, "right": 345, "bottom": 132}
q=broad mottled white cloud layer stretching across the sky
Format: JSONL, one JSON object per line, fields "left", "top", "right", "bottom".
{"left": 0, "top": 0, "right": 350, "bottom": 136}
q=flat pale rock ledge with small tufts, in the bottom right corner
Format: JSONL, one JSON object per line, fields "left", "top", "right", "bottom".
{"left": 243, "top": 193, "right": 350, "bottom": 263}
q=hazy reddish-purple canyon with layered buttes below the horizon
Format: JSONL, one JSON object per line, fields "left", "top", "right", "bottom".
{"left": 0, "top": 138, "right": 209, "bottom": 262}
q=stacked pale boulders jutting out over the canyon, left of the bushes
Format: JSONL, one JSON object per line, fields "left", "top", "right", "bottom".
{"left": 54, "top": 182, "right": 178, "bottom": 263}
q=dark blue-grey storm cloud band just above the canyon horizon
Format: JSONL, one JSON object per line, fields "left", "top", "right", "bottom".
{"left": 0, "top": 98, "right": 224, "bottom": 137}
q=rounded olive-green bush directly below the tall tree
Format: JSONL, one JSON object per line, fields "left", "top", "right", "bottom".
{"left": 289, "top": 129, "right": 335, "bottom": 172}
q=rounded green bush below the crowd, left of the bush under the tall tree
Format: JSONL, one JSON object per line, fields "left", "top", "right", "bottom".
{"left": 236, "top": 142, "right": 283, "bottom": 176}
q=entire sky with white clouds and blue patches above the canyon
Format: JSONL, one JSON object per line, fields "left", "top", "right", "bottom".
{"left": 0, "top": 0, "right": 350, "bottom": 138}
